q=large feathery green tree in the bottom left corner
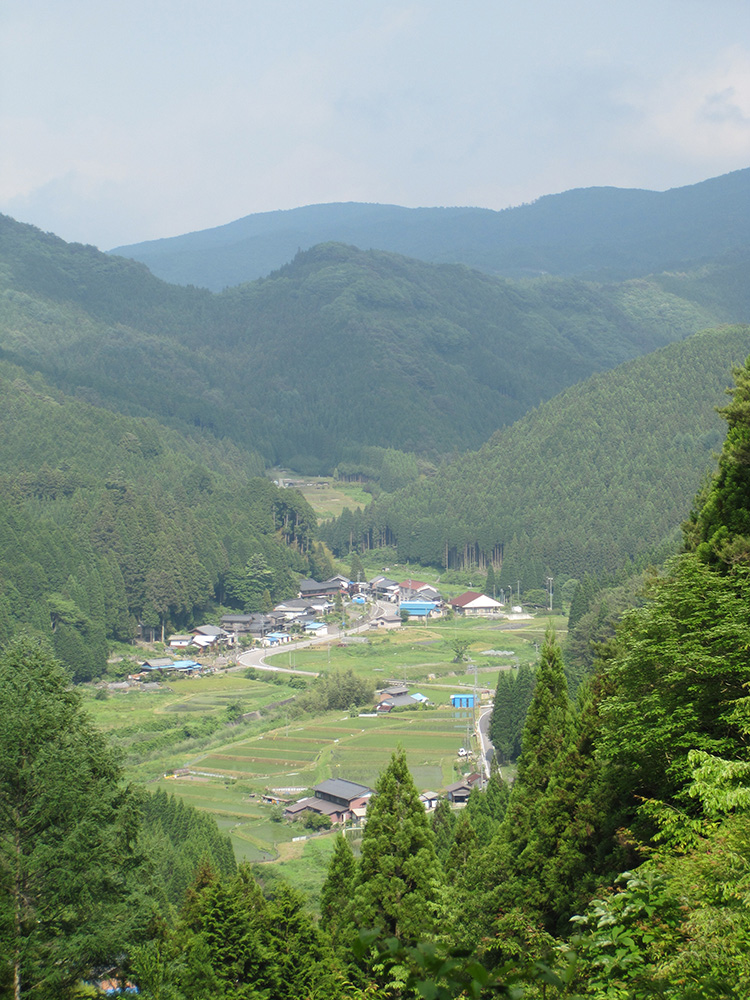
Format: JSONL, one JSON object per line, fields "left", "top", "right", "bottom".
{"left": 0, "top": 637, "right": 136, "bottom": 1000}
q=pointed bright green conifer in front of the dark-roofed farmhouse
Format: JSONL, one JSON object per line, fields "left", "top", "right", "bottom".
{"left": 353, "top": 748, "right": 440, "bottom": 943}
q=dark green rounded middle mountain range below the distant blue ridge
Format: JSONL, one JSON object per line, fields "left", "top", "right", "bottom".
{"left": 0, "top": 212, "right": 750, "bottom": 473}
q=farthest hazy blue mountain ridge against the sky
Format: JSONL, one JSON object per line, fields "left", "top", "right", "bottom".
{"left": 112, "top": 168, "right": 750, "bottom": 291}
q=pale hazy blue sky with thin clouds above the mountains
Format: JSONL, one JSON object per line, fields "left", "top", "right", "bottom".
{"left": 0, "top": 0, "right": 750, "bottom": 249}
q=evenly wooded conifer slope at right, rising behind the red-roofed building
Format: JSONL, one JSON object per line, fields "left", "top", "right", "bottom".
{"left": 322, "top": 327, "right": 750, "bottom": 588}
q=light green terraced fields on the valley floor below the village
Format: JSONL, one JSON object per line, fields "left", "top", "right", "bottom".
{"left": 86, "top": 619, "right": 564, "bottom": 891}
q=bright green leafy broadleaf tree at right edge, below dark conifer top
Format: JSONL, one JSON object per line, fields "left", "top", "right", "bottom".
{"left": 599, "top": 554, "right": 750, "bottom": 800}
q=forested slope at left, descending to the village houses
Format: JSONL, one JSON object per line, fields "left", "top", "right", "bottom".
{"left": 0, "top": 362, "right": 315, "bottom": 680}
